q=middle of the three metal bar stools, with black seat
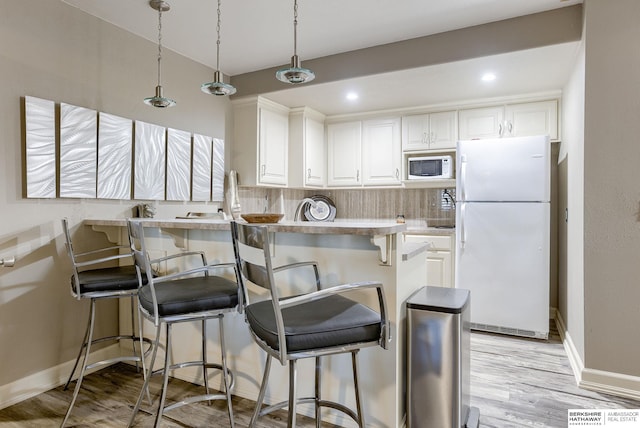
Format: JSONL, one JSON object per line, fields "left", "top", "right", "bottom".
{"left": 127, "top": 220, "right": 243, "bottom": 427}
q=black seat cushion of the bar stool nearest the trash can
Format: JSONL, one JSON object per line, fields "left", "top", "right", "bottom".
{"left": 246, "top": 295, "right": 380, "bottom": 352}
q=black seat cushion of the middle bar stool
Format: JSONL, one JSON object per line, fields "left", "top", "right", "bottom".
{"left": 138, "top": 276, "right": 238, "bottom": 317}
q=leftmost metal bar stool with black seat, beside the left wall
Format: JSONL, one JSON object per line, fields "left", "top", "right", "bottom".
{"left": 60, "top": 218, "right": 151, "bottom": 426}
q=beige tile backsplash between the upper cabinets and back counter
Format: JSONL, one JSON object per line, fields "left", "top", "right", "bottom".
{"left": 231, "top": 187, "right": 455, "bottom": 226}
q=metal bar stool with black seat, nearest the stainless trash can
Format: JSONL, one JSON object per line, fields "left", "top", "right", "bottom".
{"left": 231, "top": 222, "right": 389, "bottom": 428}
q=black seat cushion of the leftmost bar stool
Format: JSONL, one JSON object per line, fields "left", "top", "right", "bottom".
{"left": 71, "top": 266, "right": 138, "bottom": 293}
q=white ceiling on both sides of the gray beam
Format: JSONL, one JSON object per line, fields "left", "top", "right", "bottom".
{"left": 62, "top": 0, "right": 582, "bottom": 115}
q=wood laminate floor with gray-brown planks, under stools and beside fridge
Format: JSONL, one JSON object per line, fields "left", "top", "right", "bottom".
{"left": 0, "top": 322, "right": 640, "bottom": 428}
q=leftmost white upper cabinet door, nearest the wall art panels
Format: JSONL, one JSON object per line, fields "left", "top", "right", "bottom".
{"left": 258, "top": 108, "right": 289, "bottom": 186}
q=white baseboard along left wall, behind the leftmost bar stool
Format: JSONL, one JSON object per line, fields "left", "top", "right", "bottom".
{"left": 0, "top": 343, "right": 120, "bottom": 409}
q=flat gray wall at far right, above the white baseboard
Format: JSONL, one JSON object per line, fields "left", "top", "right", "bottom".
{"left": 584, "top": 0, "right": 640, "bottom": 376}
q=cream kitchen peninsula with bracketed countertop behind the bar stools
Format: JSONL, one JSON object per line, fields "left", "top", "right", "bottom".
{"left": 84, "top": 218, "right": 427, "bottom": 428}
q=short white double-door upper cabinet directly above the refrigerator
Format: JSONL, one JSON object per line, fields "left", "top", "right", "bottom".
{"left": 458, "top": 100, "right": 558, "bottom": 141}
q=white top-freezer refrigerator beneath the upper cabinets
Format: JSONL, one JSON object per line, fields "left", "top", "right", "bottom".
{"left": 455, "top": 136, "right": 551, "bottom": 339}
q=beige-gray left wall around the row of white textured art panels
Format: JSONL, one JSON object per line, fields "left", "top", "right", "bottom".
{"left": 0, "top": 0, "right": 231, "bottom": 394}
